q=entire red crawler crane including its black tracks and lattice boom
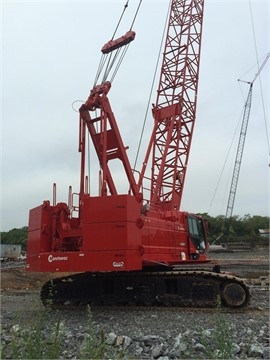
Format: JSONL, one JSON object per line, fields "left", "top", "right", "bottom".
{"left": 27, "top": 0, "right": 249, "bottom": 307}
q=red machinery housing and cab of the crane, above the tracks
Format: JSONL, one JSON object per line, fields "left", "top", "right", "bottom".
{"left": 27, "top": 195, "right": 205, "bottom": 272}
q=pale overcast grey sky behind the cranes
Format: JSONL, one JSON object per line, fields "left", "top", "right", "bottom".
{"left": 0, "top": 0, "right": 270, "bottom": 231}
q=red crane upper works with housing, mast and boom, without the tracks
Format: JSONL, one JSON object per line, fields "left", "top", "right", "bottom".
{"left": 27, "top": 0, "right": 207, "bottom": 272}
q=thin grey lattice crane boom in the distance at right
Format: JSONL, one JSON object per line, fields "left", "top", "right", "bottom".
{"left": 223, "top": 53, "right": 270, "bottom": 238}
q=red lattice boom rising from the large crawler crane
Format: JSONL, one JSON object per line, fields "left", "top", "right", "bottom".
{"left": 139, "top": 0, "right": 204, "bottom": 210}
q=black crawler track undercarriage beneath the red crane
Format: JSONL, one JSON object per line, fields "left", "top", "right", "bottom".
{"left": 41, "top": 270, "right": 250, "bottom": 308}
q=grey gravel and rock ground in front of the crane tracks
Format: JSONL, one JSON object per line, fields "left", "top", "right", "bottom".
{"left": 1, "top": 250, "right": 270, "bottom": 360}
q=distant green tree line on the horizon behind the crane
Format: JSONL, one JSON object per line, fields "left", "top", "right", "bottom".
{"left": 1, "top": 213, "right": 270, "bottom": 250}
